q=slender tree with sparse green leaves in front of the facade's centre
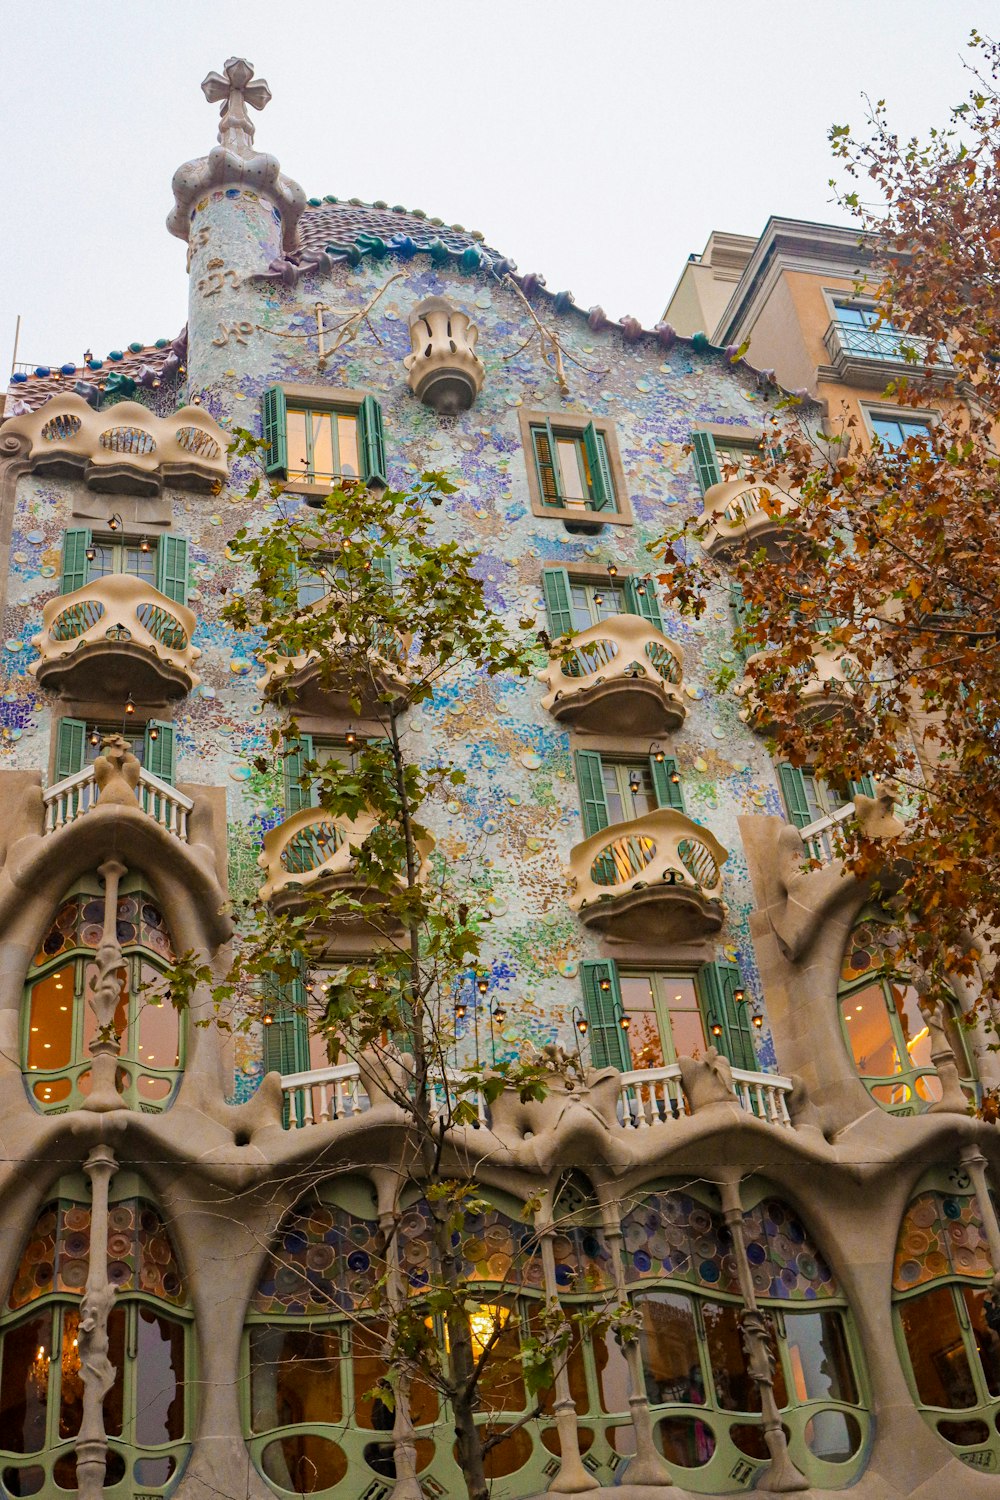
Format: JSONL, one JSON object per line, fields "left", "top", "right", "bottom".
{"left": 185, "top": 434, "right": 611, "bottom": 1500}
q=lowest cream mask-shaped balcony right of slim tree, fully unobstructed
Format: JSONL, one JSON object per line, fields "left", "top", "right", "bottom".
{"left": 570, "top": 807, "right": 729, "bottom": 942}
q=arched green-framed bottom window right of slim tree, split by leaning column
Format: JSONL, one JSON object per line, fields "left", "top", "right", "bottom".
{"left": 603, "top": 1188, "right": 868, "bottom": 1494}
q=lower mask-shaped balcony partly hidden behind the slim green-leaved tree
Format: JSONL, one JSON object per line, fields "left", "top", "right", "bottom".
{"left": 256, "top": 807, "right": 433, "bottom": 933}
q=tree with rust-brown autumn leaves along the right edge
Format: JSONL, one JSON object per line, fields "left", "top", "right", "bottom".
{"left": 661, "top": 35, "right": 1000, "bottom": 1068}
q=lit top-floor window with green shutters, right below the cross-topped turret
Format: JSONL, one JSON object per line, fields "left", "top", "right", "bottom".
{"left": 261, "top": 386, "right": 388, "bottom": 489}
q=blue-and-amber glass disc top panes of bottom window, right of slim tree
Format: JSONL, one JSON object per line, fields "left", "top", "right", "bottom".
{"left": 622, "top": 1193, "right": 837, "bottom": 1301}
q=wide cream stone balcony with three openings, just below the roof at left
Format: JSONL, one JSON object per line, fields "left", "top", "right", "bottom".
{"left": 3, "top": 392, "right": 229, "bottom": 495}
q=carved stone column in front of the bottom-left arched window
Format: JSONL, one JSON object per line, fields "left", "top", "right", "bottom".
{"left": 76, "top": 1146, "right": 118, "bottom": 1500}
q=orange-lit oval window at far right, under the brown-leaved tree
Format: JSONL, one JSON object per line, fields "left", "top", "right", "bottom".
{"left": 840, "top": 914, "right": 976, "bottom": 1115}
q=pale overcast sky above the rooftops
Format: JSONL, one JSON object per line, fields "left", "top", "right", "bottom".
{"left": 0, "top": 0, "right": 991, "bottom": 377}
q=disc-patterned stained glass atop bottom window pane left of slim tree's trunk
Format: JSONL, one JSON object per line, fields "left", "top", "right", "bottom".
{"left": 252, "top": 1203, "right": 385, "bottom": 1316}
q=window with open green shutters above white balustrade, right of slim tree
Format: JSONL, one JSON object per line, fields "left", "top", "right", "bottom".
{"left": 580, "top": 959, "right": 757, "bottom": 1073}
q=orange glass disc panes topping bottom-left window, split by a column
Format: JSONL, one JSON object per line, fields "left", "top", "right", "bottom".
{"left": 7, "top": 1199, "right": 187, "bottom": 1308}
